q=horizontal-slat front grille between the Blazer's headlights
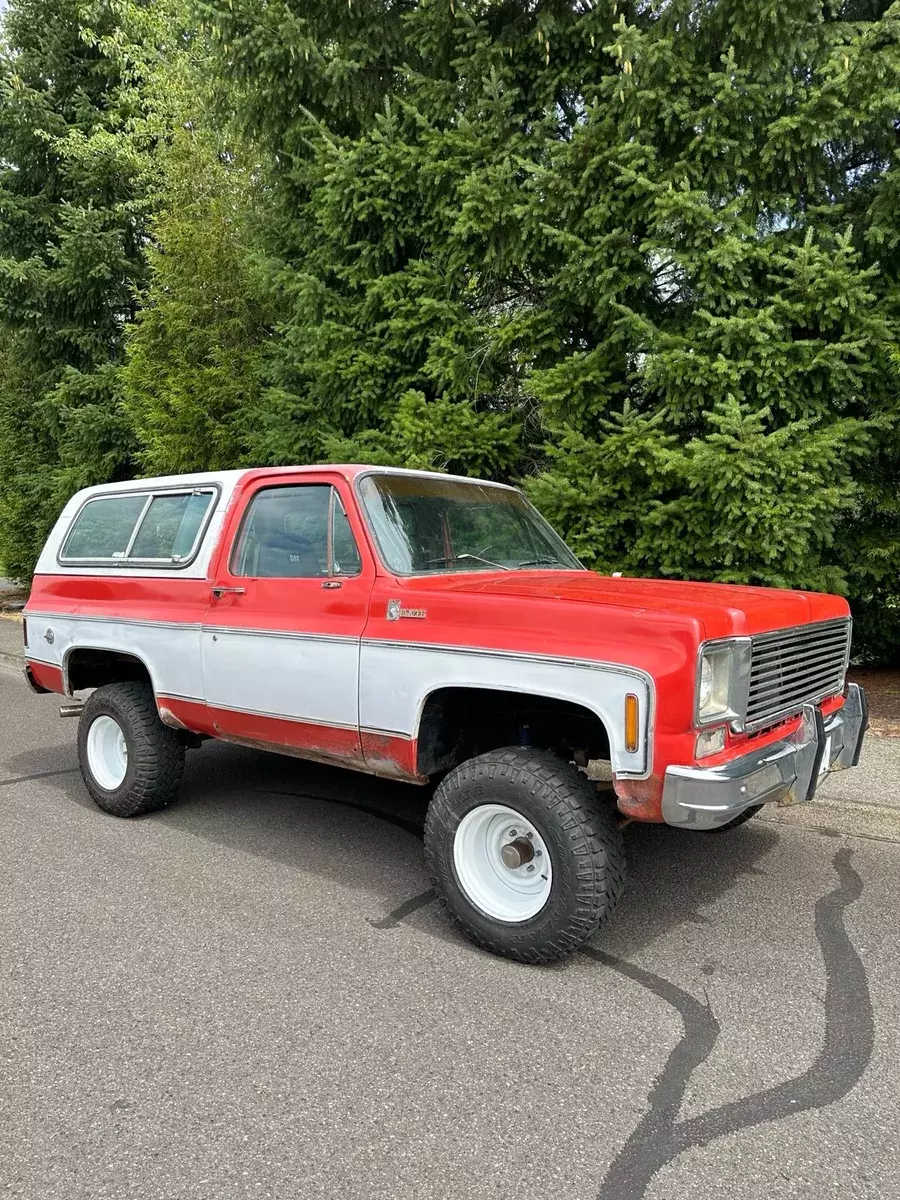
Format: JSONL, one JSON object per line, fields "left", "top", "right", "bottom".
{"left": 745, "top": 620, "right": 850, "bottom": 730}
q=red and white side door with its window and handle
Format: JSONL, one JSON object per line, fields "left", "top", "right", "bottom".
{"left": 200, "top": 473, "right": 374, "bottom": 762}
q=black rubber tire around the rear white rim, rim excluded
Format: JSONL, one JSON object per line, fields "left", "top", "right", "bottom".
{"left": 78, "top": 683, "right": 185, "bottom": 817}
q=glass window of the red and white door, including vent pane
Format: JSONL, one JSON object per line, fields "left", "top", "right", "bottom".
{"left": 232, "top": 484, "right": 362, "bottom": 580}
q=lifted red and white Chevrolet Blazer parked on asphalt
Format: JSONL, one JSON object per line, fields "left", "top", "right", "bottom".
{"left": 25, "top": 466, "right": 866, "bottom": 962}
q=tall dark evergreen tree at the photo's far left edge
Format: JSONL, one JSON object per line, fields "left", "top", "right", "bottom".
{"left": 0, "top": 0, "right": 154, "bottom": 577}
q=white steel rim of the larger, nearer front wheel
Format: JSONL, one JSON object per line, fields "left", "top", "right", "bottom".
{"left": 454, "top": 804, "right": 553, "bottom": 924}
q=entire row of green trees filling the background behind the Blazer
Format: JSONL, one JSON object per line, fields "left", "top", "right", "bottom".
{"left": 0, "top": 0, "right": 900, "bottom": 658}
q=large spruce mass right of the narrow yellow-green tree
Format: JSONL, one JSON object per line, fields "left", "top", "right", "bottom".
{"left": 202, "top": 0, "right": 900, "bottom": 657}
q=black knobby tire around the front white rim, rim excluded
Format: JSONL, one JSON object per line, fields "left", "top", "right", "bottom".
{"left": 425, "top": 748, "right": 625, "bottom": 962}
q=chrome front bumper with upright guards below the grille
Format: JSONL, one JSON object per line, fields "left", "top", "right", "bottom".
{"left": 662, "top": 683, "right": 869, "bottom": 829}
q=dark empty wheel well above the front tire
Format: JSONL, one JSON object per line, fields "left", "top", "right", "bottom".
{"left": 418, "top": 688, "right": 610, "bottom": 775}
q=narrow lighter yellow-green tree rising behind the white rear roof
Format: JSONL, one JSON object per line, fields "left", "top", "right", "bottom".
{"left": 121, "top": 127, "right": 271, "bottom": 475}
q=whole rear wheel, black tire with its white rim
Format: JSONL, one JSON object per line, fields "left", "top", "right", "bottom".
{"left": 78, "top": 683, "right": 185, "bottom": 817}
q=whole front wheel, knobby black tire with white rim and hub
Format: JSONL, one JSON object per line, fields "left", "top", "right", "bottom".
{"left": 425, "top": 748, "right": 625, "bottom": 962}
